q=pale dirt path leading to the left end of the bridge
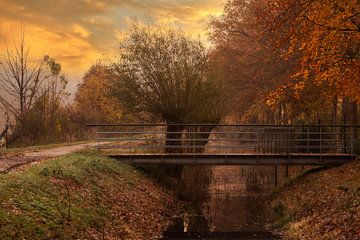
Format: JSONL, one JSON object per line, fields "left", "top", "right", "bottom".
{"left": 0, "top": 143, "right": 98, "bottom": 174}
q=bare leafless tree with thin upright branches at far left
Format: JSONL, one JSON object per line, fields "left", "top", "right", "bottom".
{"left": 0, "top": 29, "right": 47, "bottom": 125}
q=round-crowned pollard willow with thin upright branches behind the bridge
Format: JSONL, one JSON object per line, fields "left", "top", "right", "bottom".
{"left": 113, "top": 25, "right": 224, "bottom": 152}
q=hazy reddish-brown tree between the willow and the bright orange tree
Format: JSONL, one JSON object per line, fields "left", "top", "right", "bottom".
{"left": 209, "top": 0, "right": 294, "bottom": 123}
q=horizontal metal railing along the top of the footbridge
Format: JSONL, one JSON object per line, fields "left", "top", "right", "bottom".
{"left": 87, "top": 124, "right": 360, "bottom": 155}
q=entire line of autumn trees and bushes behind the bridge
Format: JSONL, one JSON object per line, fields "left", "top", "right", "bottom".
{"left": 0, "top": 0, "right": 360, "bottom": 144}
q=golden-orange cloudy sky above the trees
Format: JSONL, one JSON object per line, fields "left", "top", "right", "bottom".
{"left": 0, "top": 0, "right": 225, "bottom": 91}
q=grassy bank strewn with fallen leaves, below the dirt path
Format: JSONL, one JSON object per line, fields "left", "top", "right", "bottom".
{"left": 0, "top": 150, "right": 178, "bottom": 239}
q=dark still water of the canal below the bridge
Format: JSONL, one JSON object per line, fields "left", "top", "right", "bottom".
{"left": 164, "top": 166, "right": 299, "bottom": 240}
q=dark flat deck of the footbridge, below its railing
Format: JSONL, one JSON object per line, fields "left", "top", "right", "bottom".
{"left": 108, "top": 153, "right": 356, "bottom": 166}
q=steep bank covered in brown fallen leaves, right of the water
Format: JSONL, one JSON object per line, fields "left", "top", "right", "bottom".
{"left": 272, "top": 161, "right": 360, "bottom": 240}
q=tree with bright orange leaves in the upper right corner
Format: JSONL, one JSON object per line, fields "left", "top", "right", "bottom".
{"left": 257, "top": 0, "right": 360, "bottom": 123}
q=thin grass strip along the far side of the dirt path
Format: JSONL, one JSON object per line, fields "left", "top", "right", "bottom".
{"left": 0, "top": 141, "right": 91, "bottom": 157}
